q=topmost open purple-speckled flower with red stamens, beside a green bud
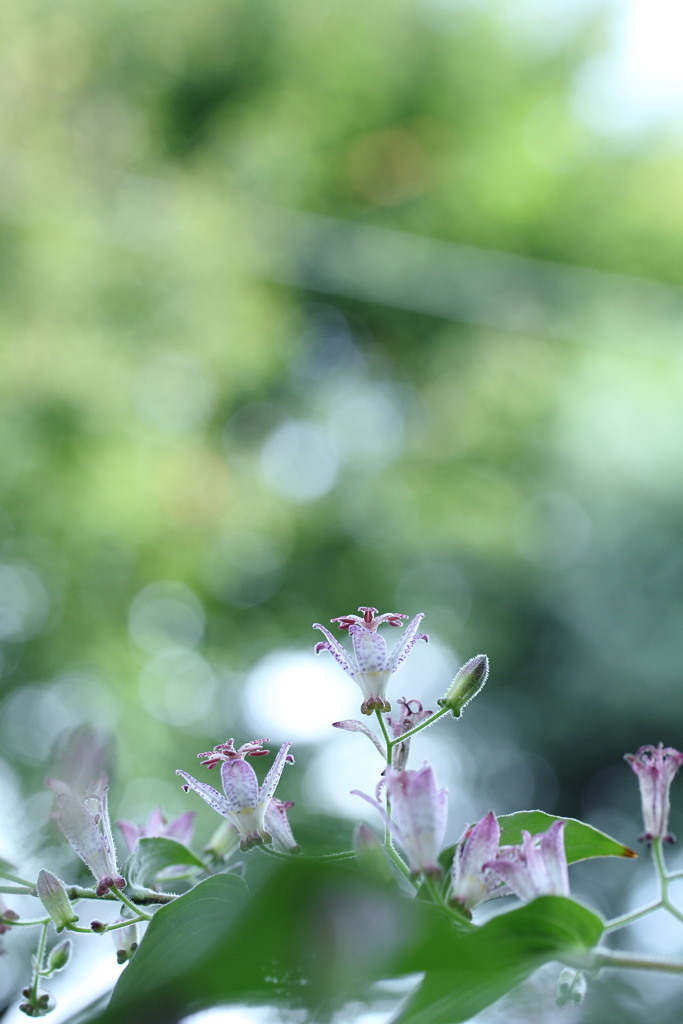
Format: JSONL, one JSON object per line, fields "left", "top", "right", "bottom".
{"left": 313, "top": 606, "right": 429, "bottom": 715}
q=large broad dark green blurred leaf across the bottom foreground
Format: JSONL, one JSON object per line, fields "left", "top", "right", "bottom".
{"left": 83, "top": 860, "right": 481, "bottom": 1024}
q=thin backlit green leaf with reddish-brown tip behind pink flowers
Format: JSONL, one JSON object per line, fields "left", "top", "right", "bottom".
{"left": 439, "top": 811, "right": 638, "bottom": 871}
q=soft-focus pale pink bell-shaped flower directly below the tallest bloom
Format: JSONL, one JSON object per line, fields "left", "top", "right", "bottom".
{"left": 351, "top": 764, "right": 449, "bottom": 879}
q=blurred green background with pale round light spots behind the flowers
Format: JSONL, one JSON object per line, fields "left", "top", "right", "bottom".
{"left": 0, "top": 0, "right": 683, "bottom": 1015}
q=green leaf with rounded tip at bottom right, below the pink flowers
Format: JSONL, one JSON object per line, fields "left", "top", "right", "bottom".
{"left": 394, "top": 896, "right": 603, "bottom": 1024}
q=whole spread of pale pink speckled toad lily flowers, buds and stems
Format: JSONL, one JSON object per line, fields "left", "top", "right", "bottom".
{"left": 9, "top": 605, "right": 683, "bottom": 1019}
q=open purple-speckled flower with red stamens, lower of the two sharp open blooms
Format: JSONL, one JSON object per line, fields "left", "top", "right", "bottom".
{"left": 176, "top": 742, "right": 294, "bottom": 850}
